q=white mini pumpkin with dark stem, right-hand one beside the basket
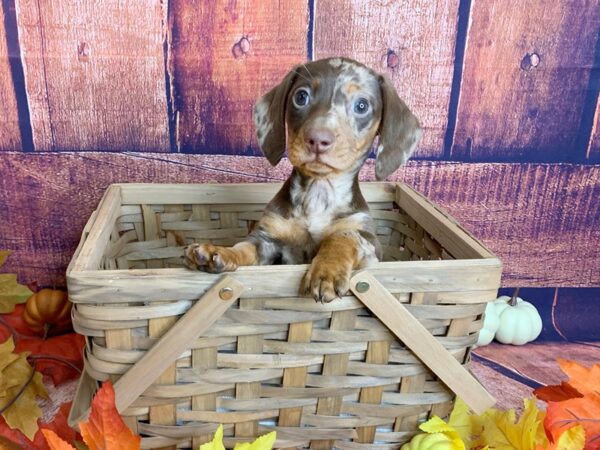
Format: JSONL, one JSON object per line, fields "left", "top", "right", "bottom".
{"left": 494, "top": 295, "right": 542, "bottom": 345}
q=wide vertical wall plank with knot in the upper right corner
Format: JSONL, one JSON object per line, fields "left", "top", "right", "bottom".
{"left": 451, "top": 0, "right": 600, "bottom": 161}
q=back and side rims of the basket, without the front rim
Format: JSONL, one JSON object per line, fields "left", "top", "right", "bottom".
{"left": 67, "top": 182, "right": 499, "bottom": 275}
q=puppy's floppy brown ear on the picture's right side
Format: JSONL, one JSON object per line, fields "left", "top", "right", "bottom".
{"left": 375, "top": 76, "right": 422, "bottom": 180}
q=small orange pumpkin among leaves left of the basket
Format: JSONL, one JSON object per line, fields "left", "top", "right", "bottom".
{"left": 23, "top": 288, "right": 72, "bottom": 335}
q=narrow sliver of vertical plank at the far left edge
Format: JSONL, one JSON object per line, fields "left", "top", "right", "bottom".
{"left": 0, "top": 2, "right": 21, "bottom": 152}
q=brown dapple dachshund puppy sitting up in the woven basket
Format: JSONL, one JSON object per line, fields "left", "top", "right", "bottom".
{"left": 184, "top": 58, "right": 421, "bottom": 302}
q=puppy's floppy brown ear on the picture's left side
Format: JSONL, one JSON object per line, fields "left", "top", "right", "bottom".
{"left": 252, "top": 68, "right": 296, "bottom": 166}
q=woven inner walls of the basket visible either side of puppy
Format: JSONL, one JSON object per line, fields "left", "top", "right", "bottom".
{"left": 103, "top": 204, "right": 453, "bottom": 269}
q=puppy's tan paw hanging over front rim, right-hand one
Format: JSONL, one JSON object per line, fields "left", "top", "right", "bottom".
{"left": 302, "top": 256, "right": 352, "bottom": 303}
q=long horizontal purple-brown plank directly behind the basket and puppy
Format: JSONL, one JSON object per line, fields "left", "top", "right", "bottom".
{"left": 0, "top": 153, "right": 600, "bottom": 287}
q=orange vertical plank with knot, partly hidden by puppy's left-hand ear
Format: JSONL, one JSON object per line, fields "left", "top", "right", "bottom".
{"left": 169, "top": 0, "right": 308, "bottom": 154}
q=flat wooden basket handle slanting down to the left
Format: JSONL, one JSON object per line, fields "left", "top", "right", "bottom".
{"left": 115, "top": 275, "right": 244, "bottom": 413}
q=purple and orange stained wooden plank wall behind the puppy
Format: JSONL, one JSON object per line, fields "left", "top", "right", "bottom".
{"left": 0, "top": 0, "right": 600, "bottom": 287}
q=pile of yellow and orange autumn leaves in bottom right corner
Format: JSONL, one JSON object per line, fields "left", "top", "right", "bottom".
{"left": 402, "top": 359, "right": 600, "bottom": 450}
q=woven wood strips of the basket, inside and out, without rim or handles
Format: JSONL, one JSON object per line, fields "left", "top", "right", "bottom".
{"left": 68, "top": 184, "right": 500, "bottom": 449}
